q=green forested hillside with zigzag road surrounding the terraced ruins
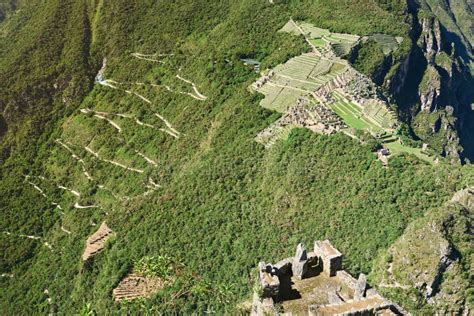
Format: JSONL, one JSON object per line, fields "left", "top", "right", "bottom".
{"left": 0, "top": 0, "right": 471, "bottom": 314}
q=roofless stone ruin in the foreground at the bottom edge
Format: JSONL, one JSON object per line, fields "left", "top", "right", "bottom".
{"left": 251, "top": 240, "right": 408, "bottom": 316}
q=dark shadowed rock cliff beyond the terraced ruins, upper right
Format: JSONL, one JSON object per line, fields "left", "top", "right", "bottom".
{"left": 386, "top": 5, "right": 474, "bottom": 160}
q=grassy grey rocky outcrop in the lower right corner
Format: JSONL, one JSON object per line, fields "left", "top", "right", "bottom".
{"left": 371, "top": 187, "right": 474, "bottom": 314}
